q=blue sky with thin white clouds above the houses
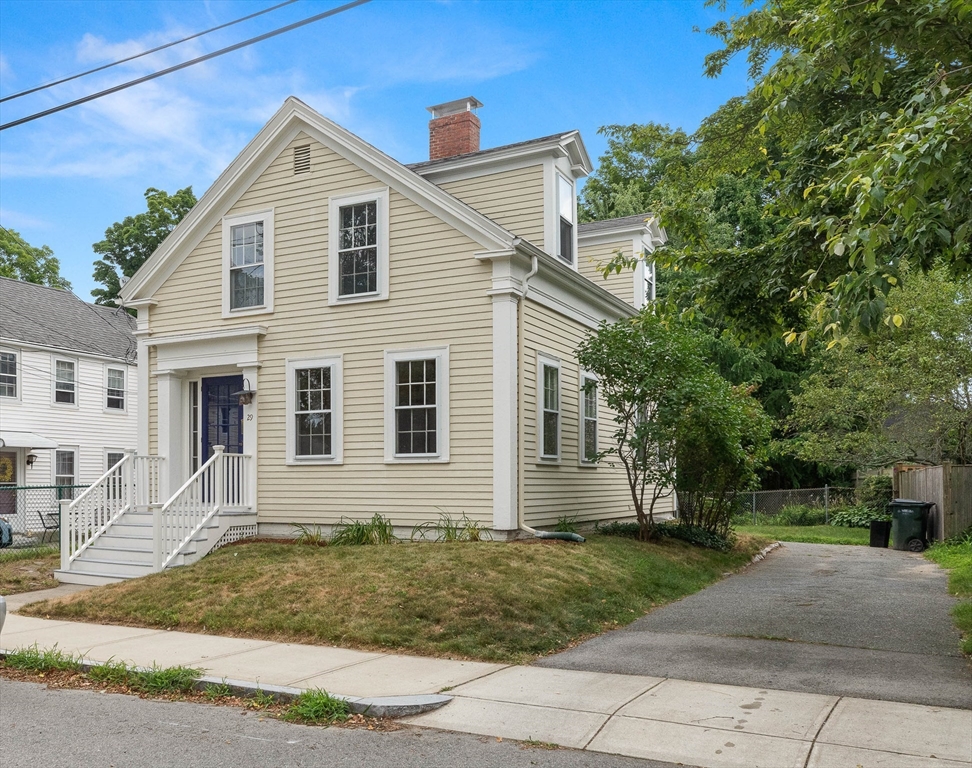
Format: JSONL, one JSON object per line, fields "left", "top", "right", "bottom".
{"left": 0, "top": 0, "right": 747, "bottom": 299}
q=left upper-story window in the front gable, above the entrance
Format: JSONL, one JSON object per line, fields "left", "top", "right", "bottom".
{"left": 223, "top": 210, "right": 273, "bottom": 317}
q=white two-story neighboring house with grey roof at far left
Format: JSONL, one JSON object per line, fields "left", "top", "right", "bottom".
{"left": 0, "top": 278, "right": 138, "bottom": 530}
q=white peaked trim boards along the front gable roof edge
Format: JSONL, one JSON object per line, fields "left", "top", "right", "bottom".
{"left": 121, "top": 96, "right": 514, "bottom": 303}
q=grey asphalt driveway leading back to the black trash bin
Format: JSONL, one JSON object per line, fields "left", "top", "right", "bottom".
{"left": 537, "top": 543, "right": 972, "bottom": 708}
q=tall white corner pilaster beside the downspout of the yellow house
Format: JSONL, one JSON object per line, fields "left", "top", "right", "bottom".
{"left": 492, "top": 291, "right": 519, "bottom": 531}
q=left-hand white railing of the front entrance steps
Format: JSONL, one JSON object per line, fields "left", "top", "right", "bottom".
{"left": 61, "top": 453, "right": 137, "bottom": 570}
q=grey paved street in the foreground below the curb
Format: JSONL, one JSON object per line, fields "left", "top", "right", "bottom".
{"left": 0, "top": 678, "right": 674, "bottom": 768}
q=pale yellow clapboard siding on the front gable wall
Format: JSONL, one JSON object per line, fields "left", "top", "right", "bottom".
{"left": 151, "top": 136, "right": 492, "bottom": 526}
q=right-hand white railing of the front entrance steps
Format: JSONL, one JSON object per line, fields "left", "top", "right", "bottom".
{"left": 153, "top": 445, "right": 250, "bottom": 570}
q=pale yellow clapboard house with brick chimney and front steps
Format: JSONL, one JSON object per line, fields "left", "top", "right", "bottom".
{"left": 58, "top": 98, "right": 664, "bottom": 583}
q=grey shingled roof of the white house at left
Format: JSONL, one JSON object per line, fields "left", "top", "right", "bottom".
{"left": 0, "top": 277, "right": 137, "bottom": 362}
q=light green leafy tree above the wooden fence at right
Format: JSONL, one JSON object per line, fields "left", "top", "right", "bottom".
{"left": 790, "top": 267, "right": 972, "bottom": 469}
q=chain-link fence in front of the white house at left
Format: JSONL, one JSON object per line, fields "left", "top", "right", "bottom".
{"left": 0, "top": 485, "right": 87, "bottom": 562}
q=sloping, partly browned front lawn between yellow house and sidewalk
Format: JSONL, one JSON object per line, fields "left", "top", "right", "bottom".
{"left": 20, "top": 535, "right": 766, "bottom": 663}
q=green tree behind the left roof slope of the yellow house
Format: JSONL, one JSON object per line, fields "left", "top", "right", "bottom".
{"left": 91, "top": 187, "right": 196, "bottom": 307}
